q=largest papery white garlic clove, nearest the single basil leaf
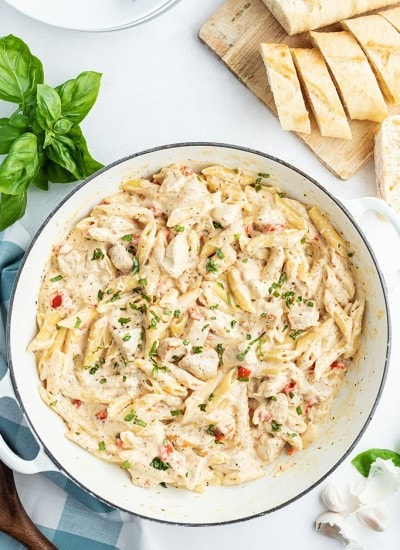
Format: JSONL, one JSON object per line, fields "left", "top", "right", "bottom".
{"left": 353, "top": 458, "right": 400, "bottom": 507}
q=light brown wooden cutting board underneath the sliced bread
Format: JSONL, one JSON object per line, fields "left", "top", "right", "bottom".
{"left": 199, "top": 0, "right": 400, "bottom": 180}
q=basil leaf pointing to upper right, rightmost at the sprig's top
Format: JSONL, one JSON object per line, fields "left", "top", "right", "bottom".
{"left": 55, "top": 71, "right": 101, "bottom": 125}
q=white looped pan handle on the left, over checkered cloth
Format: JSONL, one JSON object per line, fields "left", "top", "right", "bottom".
{"left": 0, "top": 372, "right": 59, "bottom": 474}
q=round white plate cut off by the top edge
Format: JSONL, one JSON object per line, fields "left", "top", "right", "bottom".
{"left": 6, "top": 0, "right": 180, "bottom": 31}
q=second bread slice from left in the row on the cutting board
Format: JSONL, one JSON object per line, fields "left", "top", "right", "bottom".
{"left": 291, "top": 48, "right": 352, "bottom": 139}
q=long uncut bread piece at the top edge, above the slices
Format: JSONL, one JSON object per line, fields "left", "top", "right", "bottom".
{"left": 263, "top": 0, "right": 396, "bottom": 35}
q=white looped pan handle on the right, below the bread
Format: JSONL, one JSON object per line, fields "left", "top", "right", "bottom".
{"left": 342, "top": 197, "right": 400, "bottom": 292}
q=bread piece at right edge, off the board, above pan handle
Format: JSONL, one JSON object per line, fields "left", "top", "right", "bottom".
{"left": 374, "top": 115, "right": 400, "bottom": 214}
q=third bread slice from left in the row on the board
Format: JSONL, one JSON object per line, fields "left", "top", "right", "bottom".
{"left": 310, "top": 31, "right": 388, "bottom": 122}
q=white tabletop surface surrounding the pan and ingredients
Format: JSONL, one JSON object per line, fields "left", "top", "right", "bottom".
{"left": 0, "top": 0, "right": 400, "bottom": 550}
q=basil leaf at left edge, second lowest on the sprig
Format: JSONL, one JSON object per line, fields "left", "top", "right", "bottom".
{"left": 0, "top": 132, "right": 40, "bottom": 195}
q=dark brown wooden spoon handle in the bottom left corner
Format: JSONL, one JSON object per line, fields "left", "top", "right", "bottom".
{"left": 0, "top": 461, "right": 57, "bottom": 550}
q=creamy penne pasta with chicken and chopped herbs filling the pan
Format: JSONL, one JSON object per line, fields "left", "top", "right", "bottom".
{"left": 28, "top": 163, "right": 364, "bottom": 491}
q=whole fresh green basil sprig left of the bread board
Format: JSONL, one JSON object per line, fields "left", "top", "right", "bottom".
{"left": 0, "top": 34, "right": 103, "bottom": 231}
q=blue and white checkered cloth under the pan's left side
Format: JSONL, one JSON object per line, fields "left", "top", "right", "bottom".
{"left": 0, "top": 223, "right": 154, "bottom": 550}
